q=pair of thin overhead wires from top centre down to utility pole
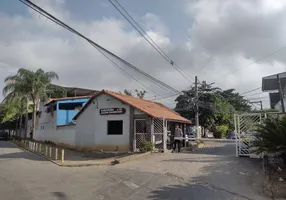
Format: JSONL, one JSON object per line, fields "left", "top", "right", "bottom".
{"left": 109, "top": 0, "right": 194, "bottom": 81}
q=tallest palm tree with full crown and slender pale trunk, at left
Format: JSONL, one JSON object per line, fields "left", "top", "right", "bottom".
{"left": 3, "top": 68, "right": 62, "bottom": 139}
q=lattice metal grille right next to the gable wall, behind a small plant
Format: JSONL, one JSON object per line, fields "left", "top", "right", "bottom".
{"left": 134, "top": 119, "right": 147, "bottom": 151}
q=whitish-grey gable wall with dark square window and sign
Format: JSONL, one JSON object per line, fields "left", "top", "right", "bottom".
{"left": 75, "top": 94, "right": 130, "bottom": 151}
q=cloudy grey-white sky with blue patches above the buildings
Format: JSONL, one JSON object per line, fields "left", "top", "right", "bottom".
{"left": 0, "top": 0, "right": 286, "bottom": 107}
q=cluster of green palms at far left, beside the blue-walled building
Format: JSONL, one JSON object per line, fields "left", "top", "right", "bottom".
{"left": 2, "top": 68, "right": 66, "bottom": 138}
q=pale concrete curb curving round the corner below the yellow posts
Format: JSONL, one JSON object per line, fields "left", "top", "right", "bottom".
{"left": 9, "top": 141, "right": 152, "bottom": 167}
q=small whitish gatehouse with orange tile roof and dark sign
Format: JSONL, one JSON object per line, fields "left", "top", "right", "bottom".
{"left": 74, "top": 90, "right": 191, "bottom": 151}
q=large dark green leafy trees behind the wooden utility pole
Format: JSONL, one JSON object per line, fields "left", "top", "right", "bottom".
{"left": 175, "top": 85, "right": 251, "bottom": 134}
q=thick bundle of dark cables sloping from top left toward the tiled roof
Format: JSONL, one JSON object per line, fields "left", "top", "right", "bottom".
{"left": 19, "top": 0, "right": 179, "bottom": 96}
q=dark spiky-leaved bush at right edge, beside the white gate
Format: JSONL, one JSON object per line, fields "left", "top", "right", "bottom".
{"left": 252, "top": 117, "right": 286, "bottom": 164}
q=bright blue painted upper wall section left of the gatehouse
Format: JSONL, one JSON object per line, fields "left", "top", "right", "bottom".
{"left": 57, "top": 98, "right": 88, "bottom": 126}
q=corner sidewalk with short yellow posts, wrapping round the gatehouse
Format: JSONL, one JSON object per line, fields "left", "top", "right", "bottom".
{"left": 12, "top": 140, "right": 150, "bottom": 167}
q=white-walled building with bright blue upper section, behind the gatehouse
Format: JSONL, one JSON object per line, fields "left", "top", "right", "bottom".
{"left": 34, "top": 96, "right": 90, "bottom": 146}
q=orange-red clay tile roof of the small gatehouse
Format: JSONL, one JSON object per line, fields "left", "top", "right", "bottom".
{"left": 74, "top": 90, "right": 191, "bottom": 123}
